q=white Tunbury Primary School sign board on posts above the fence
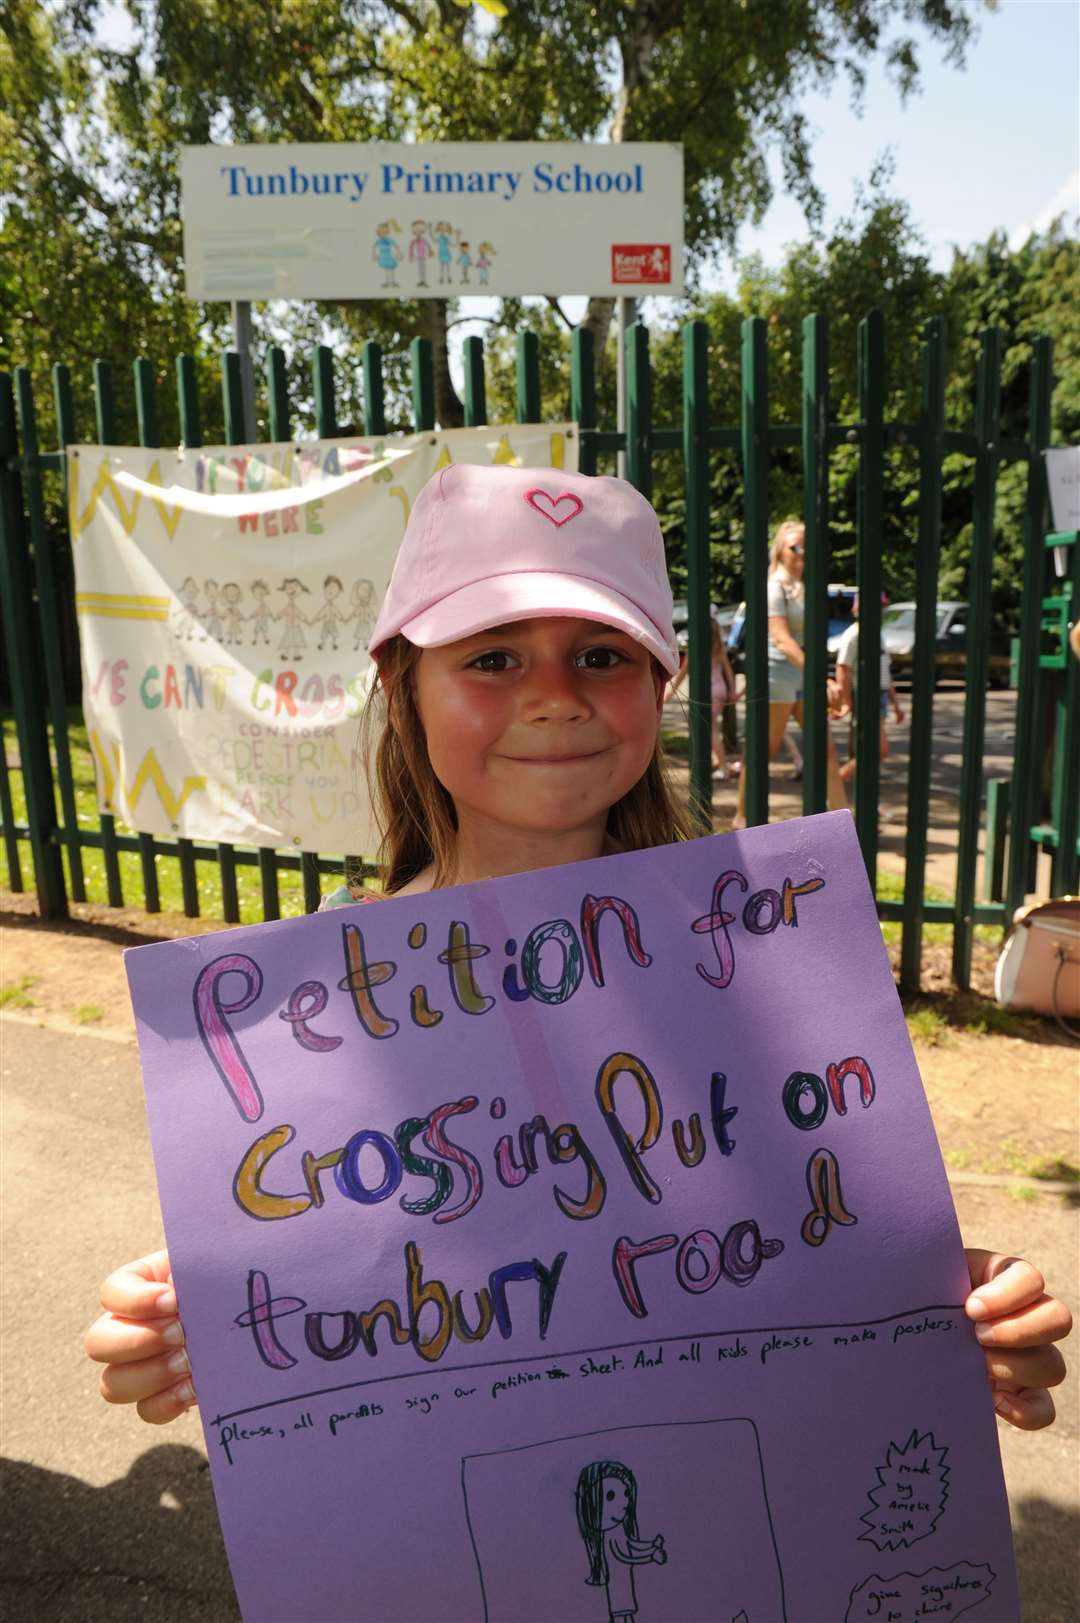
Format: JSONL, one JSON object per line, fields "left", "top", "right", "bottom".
{"left": 180, "top": 141, "right": 682, "bottom": 300}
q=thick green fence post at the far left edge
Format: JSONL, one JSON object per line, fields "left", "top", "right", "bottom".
{"left": 0, "top": 372, "right": 68, "bottom": 919}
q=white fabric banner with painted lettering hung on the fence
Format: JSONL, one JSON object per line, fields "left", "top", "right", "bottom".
{"left": 67, "top": 424, "right": 578, "bottom": 857}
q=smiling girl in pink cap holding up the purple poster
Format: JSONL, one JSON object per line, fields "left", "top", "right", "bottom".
{"left": 86, "top": 466, "right": 1070, "bottom": 1428}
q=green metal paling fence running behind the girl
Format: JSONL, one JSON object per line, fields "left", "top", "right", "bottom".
{"left": 0, "top": 312, "right": 1080, "bottom": 988}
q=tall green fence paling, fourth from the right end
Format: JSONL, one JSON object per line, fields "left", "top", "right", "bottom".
{"left": 854, "top": 310, "right": 885, "bottom": 891}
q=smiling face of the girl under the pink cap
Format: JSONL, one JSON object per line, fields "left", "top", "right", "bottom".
{"left": 416, "top": 618, "right": 664, "bottom": 860}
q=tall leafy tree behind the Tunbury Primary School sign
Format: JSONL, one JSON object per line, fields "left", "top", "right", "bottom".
{"left": 0, "top": 0, "right": 991, "bottom": 441}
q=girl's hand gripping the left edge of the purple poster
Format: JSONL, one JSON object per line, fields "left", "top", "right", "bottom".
{"left": 84, "top": 1251, "right": 195, "bottom": 1425}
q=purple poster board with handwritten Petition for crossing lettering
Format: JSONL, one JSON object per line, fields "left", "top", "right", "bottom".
{"left": 127, "top": 813, "right": 1018, "bottom": 1623}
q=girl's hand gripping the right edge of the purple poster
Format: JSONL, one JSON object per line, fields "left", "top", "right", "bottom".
{"left": 965, "top": 1250, "right": 1072, "bottom": 1431}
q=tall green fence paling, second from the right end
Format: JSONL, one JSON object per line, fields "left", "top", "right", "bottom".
{"left": 952, "top": 326, "right": 1002, "bottom": 992}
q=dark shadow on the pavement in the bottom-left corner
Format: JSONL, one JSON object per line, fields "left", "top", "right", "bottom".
{"left": 0, "top": 1444, "right": 239, "bottom": 1623}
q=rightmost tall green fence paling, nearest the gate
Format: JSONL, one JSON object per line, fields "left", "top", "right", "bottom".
{"left": 1005, "top": 338, "right": 1054, "bottom": 925}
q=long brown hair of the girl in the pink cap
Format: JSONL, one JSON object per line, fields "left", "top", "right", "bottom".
{"left": 361, "top": 636, "right": 690, "bottom": 896}
